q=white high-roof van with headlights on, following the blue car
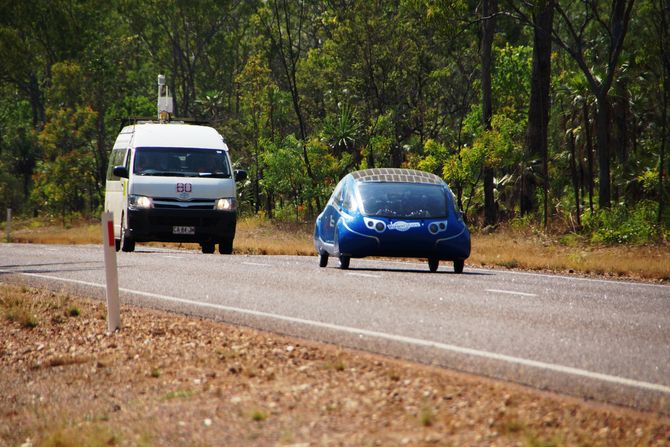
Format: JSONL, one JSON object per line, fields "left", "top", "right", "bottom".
{"left": 105, "top": 122, "right": 246, "bottom": 254}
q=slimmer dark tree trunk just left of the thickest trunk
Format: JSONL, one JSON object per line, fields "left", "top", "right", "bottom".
{"left": 481, "top": 0, "right": 497, "bottom": 225}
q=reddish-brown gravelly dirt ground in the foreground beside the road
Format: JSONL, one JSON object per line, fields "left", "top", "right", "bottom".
{"left": 0, "top": 284, "right": 670, "bottom": 447}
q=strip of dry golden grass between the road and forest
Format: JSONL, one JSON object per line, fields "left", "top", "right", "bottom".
{"left": 5, "top": 217, "right": 670, "bottom": 282}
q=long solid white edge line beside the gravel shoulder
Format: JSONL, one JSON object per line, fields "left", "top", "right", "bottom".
{"left": 5, "top": 270, "right": 670, "bottom": 395}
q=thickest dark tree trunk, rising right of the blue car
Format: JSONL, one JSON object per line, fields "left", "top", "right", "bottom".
{"left": 520, "top": 0, "right": 554, "bottom": 215}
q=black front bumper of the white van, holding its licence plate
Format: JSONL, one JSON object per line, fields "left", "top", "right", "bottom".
{"left": 127, "top": 208, "right": 237, "bottom": 243}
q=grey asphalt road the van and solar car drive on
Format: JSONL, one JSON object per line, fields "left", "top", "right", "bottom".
{"left": 0, "top": 244, "right": 670, "bottom": 414}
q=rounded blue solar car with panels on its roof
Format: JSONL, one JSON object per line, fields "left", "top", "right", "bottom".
{"left": 314, "top": 168, "right": 470, "bottom": 273}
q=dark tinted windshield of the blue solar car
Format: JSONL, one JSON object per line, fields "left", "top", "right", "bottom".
{"left": 358, "top": 182, "right": 447, "bottom": 219}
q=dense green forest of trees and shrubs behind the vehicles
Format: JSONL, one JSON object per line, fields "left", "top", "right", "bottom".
{"left": 0, "top": 0, "right": 670, "bottom": 242}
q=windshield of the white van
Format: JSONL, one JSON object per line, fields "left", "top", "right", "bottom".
{"left": 133, "top": 147, "right": 230, "bottom": 178}
